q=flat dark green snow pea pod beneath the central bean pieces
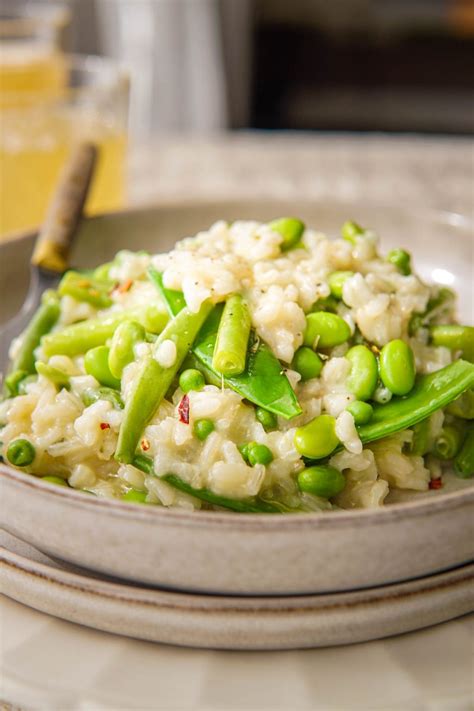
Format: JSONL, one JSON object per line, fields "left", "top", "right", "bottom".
{"left": 149, "top": 269, "right": 301, "bottom": 420}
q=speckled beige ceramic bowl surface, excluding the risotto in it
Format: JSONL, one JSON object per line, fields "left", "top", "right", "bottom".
{"left": 0, "top": 201, "right": 474, "bottom": 595}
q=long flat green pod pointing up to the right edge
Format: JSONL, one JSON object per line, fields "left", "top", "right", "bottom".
{"left": 357, "top": 360, "right": 474, "bottom": 443}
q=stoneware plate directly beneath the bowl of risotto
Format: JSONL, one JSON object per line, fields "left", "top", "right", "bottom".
{"left": 0, "top": 535, "right": 474, "bottom": 650}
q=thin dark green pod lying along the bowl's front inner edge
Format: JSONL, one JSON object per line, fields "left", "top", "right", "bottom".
{"left": 132, "top": 454, "right": 280, "bottom": 513}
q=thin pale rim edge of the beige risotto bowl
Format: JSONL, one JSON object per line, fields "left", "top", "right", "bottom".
{"left": 0, "top": 195, "right": 474, "bottom": 530}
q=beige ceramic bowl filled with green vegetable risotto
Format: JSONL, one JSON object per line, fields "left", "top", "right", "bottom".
{"left": 0, "top": 197, "right": 474, "bottom": 594}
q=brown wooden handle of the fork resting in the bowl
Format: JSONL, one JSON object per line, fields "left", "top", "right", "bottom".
{"left": 31, "top": 143, "right": 97, "bottom": 274}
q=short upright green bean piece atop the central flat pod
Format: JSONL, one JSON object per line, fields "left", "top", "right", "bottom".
{"left": 212, "top": 294, "right": 251, "bottom": 376}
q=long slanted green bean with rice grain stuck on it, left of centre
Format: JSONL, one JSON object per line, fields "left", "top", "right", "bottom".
{"left": 115, "top": 302, "right": 213, "bottom": 464}
